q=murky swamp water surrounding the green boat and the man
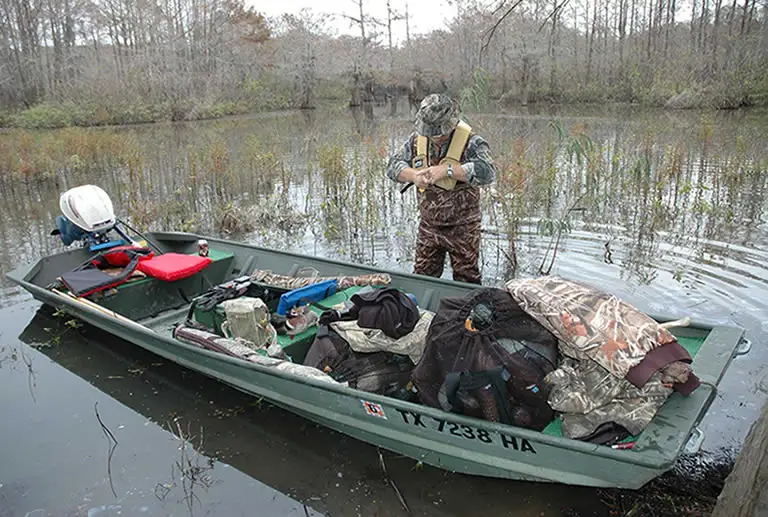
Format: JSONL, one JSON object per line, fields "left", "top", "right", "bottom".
{"left": 0, "top": 103, "right": 768, "bottom": 516}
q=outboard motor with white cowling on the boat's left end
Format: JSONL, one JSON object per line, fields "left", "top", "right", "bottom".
{"left": 51, "top": 185, "right": 133, "bottom": 251}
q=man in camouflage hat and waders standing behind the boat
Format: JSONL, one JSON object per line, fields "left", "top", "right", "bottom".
{"left": 387, "top": 94, "right": 496, "bottom": 284}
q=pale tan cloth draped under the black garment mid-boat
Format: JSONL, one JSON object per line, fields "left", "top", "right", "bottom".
{"left": 330, "top": 310, "right": 434, "bottom": 364}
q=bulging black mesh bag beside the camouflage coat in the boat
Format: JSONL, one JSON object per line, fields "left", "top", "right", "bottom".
{"left": 412, "top": 288, "right": 557, "bottom": 430}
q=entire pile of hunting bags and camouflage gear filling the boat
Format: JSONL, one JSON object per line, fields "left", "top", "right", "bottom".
{"left": 176, "top": 251, "right": 700, "bottom": 445}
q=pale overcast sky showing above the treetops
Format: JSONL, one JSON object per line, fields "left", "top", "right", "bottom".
{"left": 252, "top": 0, "right": 455, "bottom": 42}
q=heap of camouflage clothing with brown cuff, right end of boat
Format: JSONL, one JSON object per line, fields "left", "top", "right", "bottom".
{"left": 505, "top": 276, "right": 700, "bottom": 438}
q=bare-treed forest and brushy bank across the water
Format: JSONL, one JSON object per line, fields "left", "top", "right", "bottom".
{"left": 0, "top": 0, "right": 768, "bottom": 128}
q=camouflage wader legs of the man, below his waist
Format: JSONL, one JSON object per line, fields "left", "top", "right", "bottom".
{"left": 413, "top": 220, "right": 481, "bottom": 284}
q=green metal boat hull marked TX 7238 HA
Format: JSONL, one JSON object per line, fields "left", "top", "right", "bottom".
{"left": 8, "top": 234, "right": 742, "bottom": 489}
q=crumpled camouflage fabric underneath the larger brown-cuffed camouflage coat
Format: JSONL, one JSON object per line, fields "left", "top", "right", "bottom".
{"left": 544, "top": 359, "right": 672, "bottom": 438}
